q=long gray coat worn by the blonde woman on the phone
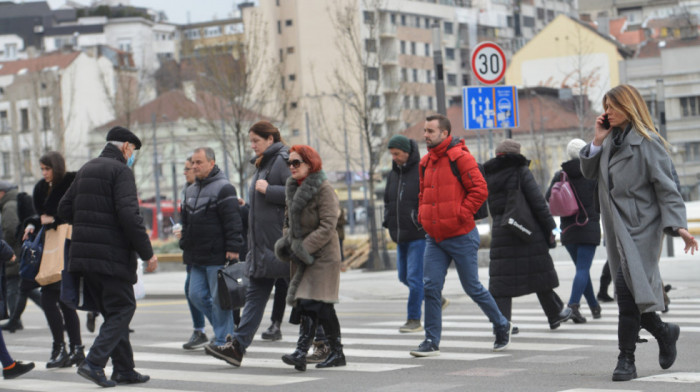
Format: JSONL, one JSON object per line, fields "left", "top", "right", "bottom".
{"left": 580, "top": 128, "right": 687, "bottom": 313}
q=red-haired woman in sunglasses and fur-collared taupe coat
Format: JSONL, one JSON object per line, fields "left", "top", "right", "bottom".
{"left": 275, "top": 146, "right": 345, "bottom": 371}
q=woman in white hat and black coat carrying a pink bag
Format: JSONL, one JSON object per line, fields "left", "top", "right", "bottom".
{"left": 545, "top": 139, "right": 600, "bottom": 324}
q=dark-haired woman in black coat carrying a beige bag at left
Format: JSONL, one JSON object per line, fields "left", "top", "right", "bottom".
{"left": 22, "top": 151, "right": 85, "bottom": 368}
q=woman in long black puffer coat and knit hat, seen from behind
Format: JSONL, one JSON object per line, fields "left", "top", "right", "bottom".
{"left": 484, "top": 139, "right": 571, "bottom": 329}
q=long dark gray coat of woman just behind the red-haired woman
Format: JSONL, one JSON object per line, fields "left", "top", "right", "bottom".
{"left": 246, "top": 143, "right": 290, "bottom": 278}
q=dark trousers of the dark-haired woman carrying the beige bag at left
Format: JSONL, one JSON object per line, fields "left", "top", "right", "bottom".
{"left": 41, "top": 282, "right": 83, "bottom": 346}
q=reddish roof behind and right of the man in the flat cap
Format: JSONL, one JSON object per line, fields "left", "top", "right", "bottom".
{"left": 96, "top": 90, "right": 269, "bottom": 131}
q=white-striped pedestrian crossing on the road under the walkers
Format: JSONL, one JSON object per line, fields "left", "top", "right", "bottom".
{"left": 0, "top": 299, "right": 700, "bottom": 392}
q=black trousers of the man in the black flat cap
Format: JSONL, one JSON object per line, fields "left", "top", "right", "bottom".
{"left": 84, "top": 273, "right": 136, "bottom": 373}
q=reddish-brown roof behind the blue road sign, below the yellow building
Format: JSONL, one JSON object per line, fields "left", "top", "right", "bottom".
{"left": 401, "top": 88, "right": 595, "bottom": 140}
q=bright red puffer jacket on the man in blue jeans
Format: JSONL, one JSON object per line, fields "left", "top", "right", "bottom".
{"left": 418, "top": 136, "right": 488, "bottom": 242}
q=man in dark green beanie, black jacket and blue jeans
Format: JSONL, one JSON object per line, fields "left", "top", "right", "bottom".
{"left": 384, "top": 135, "right": 425, "bottom": 332}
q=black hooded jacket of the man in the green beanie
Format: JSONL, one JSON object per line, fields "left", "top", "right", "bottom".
{"left": 383, "top": 140, "right": 425, "bottom": 242}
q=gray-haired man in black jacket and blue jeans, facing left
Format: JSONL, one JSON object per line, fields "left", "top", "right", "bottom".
{"left": 180, "top": 147, "right": 243, "bottom": 354}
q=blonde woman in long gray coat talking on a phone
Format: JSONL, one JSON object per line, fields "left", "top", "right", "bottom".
{"left": 580, "top": 85, "right": 698, "bottom": 381}
